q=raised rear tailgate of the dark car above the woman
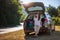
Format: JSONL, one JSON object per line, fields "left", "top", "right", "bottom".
{"left": 23, "top": 2, "right": 45, "bottom": 14}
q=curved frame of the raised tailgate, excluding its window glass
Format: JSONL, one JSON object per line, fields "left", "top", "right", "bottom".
{"left": 23, "top": 2, "right": 45, "bottom": 12}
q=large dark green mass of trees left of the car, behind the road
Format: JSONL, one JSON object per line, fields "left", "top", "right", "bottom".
{"left": 0, "top": 0, "right": 22, "bottom": 27}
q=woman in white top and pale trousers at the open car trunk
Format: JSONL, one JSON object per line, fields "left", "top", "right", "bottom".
{"left": 34, "top": 12, "right": 42, "bottom": 36}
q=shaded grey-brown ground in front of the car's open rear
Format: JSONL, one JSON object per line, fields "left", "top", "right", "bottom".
{"left": 25, "top": 26, "right": 60, "bottom": 40}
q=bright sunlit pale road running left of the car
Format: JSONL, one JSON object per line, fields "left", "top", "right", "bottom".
{"left": 0, "top": 23, "right": 23, "bottom": 34}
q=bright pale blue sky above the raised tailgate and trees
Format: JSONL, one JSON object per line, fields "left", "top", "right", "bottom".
{"left": 19, "top": 0, "right": 60, "bottom": 8}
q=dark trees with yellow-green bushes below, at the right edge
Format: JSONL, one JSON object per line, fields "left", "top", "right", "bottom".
{"left": 46, "top": 5, "right": 60, "bottom": 25}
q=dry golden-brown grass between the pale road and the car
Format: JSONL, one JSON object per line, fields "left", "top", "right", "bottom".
{"left": 0, "top": 30, "right": 25, "bottom": 40}
